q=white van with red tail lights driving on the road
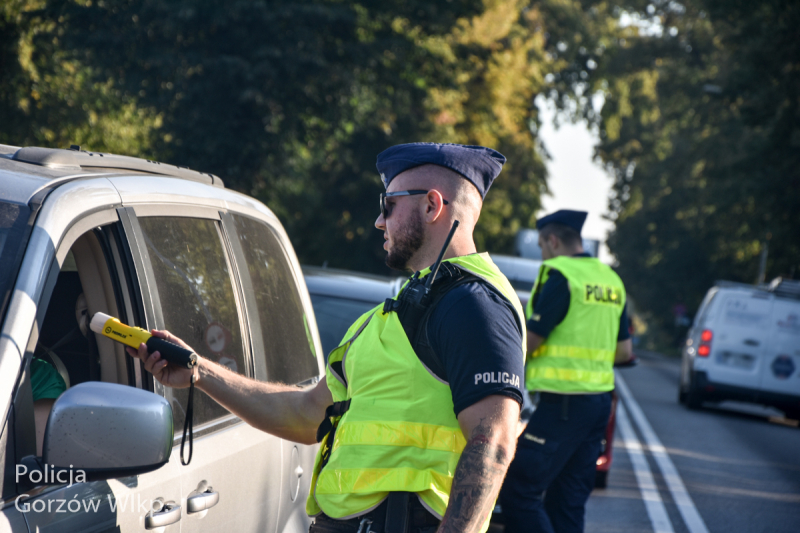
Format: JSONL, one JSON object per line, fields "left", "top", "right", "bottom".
{"left": 678, "top": 278, "right": 800, "bottom": 419}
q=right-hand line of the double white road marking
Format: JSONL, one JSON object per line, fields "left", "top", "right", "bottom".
{"left": 616, "top": 372, "right": 708, "bottom": 533}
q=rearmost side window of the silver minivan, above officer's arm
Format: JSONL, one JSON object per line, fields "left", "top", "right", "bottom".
{"left": 233, "top": 215, "right": 319, "bottom": 383}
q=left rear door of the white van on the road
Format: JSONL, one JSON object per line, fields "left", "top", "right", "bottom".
{"left": 708, "top": 291, "right": 772, "bottom": 390}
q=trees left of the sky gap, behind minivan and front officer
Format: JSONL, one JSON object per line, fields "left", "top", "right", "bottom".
{"left": 0, "top": 0, "right": 547, "bottom": 271}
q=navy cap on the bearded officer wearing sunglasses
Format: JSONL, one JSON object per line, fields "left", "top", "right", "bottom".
{"left": 375, "top": 143, "right": 506, "bottom": 198}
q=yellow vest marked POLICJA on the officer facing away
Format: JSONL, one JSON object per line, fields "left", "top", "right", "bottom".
{"left": 525, "top": 256, "right": 625, "bottom": 394}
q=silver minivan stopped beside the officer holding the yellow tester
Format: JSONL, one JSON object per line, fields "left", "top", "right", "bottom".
{"left": 0, "top": 145, "right": 323, "bottom": 533}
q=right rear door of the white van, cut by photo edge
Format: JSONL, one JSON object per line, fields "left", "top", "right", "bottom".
{"left": 759, "top": 298, "right": 800, "bottom": 397}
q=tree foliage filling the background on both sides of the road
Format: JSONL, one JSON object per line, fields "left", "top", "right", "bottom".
{"left": 0, "top": 0, "right": 800, "bottom": 340}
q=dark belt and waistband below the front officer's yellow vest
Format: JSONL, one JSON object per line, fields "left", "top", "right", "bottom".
{"left": 309, "top": 492, "right": 440, "bottom": 533}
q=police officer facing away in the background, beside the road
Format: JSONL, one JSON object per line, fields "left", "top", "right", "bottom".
{"left": 500, "top": 210, "right": 632, "bottom": 533}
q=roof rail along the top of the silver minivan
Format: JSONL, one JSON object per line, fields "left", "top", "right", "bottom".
{"left": 11, "top": 144, "right": 225, "bottom": 187}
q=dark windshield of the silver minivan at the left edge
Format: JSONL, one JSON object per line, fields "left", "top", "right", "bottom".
{"left": 0, "top": 202, "right": 31, "bottom": 317}
